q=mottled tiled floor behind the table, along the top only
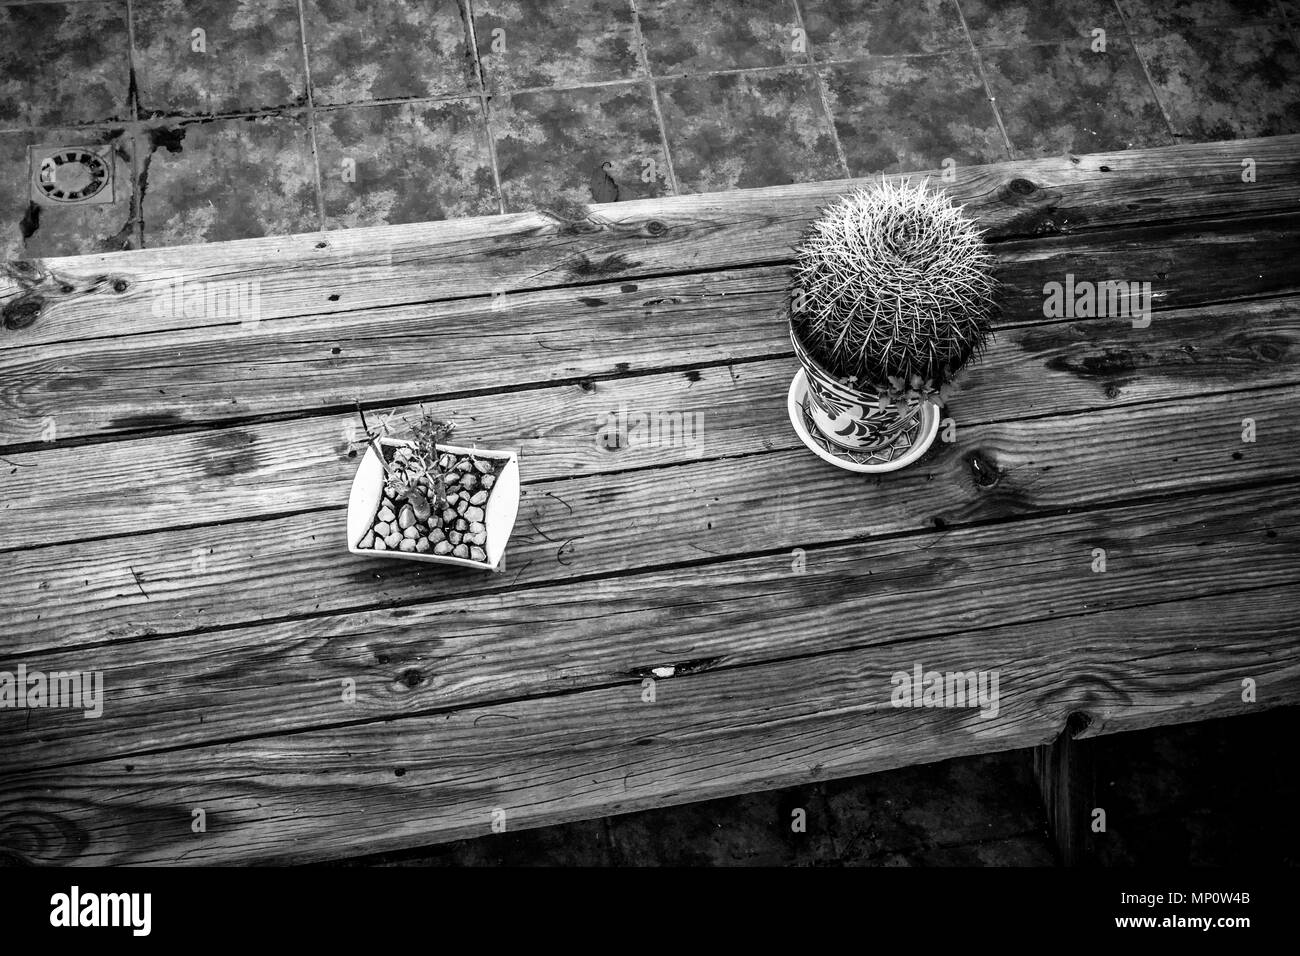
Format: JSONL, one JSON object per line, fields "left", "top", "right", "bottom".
{"left": 0, "top": 0, "right": 1300, "bottom": 258}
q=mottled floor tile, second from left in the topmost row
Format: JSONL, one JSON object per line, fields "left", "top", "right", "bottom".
{"left": 131, "top": 0, "right": 307, "bottom": 116}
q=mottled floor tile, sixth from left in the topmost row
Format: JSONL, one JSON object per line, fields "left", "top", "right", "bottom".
{"left": 800, "top": 0, "right": 967, "bottom": 61}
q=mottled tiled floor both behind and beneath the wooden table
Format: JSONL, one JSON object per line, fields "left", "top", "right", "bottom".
{"left": 10, "top": 0, "right": 1300, "bottom": 865}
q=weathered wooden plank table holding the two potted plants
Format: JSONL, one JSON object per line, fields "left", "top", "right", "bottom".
{"left": 0, "top": 137, "right": 1300, "bottom": 864}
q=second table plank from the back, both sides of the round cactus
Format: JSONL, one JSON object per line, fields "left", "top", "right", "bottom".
{"left": 0, "top": 216, "right": 1300, "bottom": 447}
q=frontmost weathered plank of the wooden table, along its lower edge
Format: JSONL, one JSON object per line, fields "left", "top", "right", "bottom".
{"left": 0, "top": 587, "right": 1300, "bottom": 864}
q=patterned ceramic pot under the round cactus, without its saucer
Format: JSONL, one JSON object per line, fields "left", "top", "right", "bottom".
{"left": 790, "top": 321, "right": 924, "bottom": 451}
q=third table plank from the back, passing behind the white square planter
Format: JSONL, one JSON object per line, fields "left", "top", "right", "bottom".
{"left": 0, "top": 291, "right": 1300, "bottom": 550}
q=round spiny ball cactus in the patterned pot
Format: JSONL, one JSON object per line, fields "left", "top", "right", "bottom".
{"left": 790, "top": 179, "right": 995, "bottom": 398}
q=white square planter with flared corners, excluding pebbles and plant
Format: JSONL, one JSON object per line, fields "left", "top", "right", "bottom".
{"left": 347, "top": 438, "right": 519, "bottom": 571}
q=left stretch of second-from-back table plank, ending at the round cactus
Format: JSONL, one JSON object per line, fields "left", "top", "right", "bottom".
{"left": 0, "top": 271, "right": 790, "bottom": 445}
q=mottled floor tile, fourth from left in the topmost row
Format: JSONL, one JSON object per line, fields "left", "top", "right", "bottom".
{"left": 473, "top": 0, "right": 642, "bottom": 91}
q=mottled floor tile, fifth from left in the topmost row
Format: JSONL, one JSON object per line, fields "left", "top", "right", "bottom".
{"left": 637, "top": 0, "right": 809, "bottom": 77}
